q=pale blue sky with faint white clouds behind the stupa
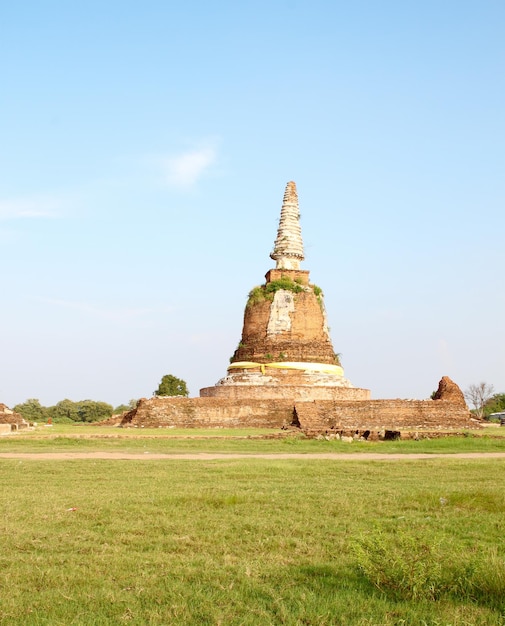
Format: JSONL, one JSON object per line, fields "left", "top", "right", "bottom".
{"left": 0, "top": 0, "right": 505, "bottom": 406}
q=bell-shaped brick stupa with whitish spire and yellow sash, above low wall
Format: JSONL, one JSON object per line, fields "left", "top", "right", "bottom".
{"left": 200, "top": 182, "right": 370, "bottom": 400}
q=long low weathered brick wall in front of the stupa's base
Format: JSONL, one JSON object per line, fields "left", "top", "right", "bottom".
{"left": 123, "top": 397, "right": 476, "bottom": 430}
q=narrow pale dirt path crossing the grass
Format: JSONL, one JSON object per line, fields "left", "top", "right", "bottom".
{"left": 0, "top": 452, "right": 505, "bottom": 461}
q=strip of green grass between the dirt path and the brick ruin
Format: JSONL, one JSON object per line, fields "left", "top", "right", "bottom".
{"left": 0, "top": 424, "right": 505, "bottom": 454}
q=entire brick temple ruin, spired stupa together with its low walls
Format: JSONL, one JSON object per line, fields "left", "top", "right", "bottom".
{"left": 121, "top": 182, "right": 477, "bottom": 434}
